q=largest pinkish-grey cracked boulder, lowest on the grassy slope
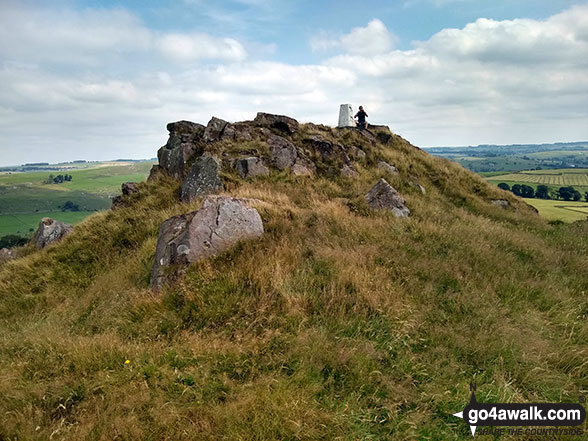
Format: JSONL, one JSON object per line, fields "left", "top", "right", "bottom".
{"left": 151, "top": 196, "right": 264, "bottom": 289}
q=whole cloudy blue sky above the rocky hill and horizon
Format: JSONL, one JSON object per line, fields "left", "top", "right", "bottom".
{"left": 0, "top": 0, "right": 588, "bottom": 165}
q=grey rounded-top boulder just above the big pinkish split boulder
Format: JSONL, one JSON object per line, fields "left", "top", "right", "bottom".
{"left": 180, "top": 156, "right": 223, "bottom": 202}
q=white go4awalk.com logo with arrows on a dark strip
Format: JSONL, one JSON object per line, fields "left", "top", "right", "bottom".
{"left": 453, "top": 384, "right": 586, "bottom": 436}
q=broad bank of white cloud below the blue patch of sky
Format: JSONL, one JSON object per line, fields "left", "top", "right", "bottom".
{"left": 0, "top": 3, "right": 588, "bottom": 164}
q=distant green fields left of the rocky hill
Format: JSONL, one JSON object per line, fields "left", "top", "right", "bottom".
{"left": 0, "top": 162, "right": 153, "bottom": 236}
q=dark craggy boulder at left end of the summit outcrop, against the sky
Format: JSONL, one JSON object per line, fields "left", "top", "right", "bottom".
{"left": 157, "top": 121, "right": 206, "bottom": 178}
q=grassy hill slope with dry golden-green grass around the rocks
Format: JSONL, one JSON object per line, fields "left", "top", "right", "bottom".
{"left": 0, "top": 125, "right": 588, "bottom": 440}
